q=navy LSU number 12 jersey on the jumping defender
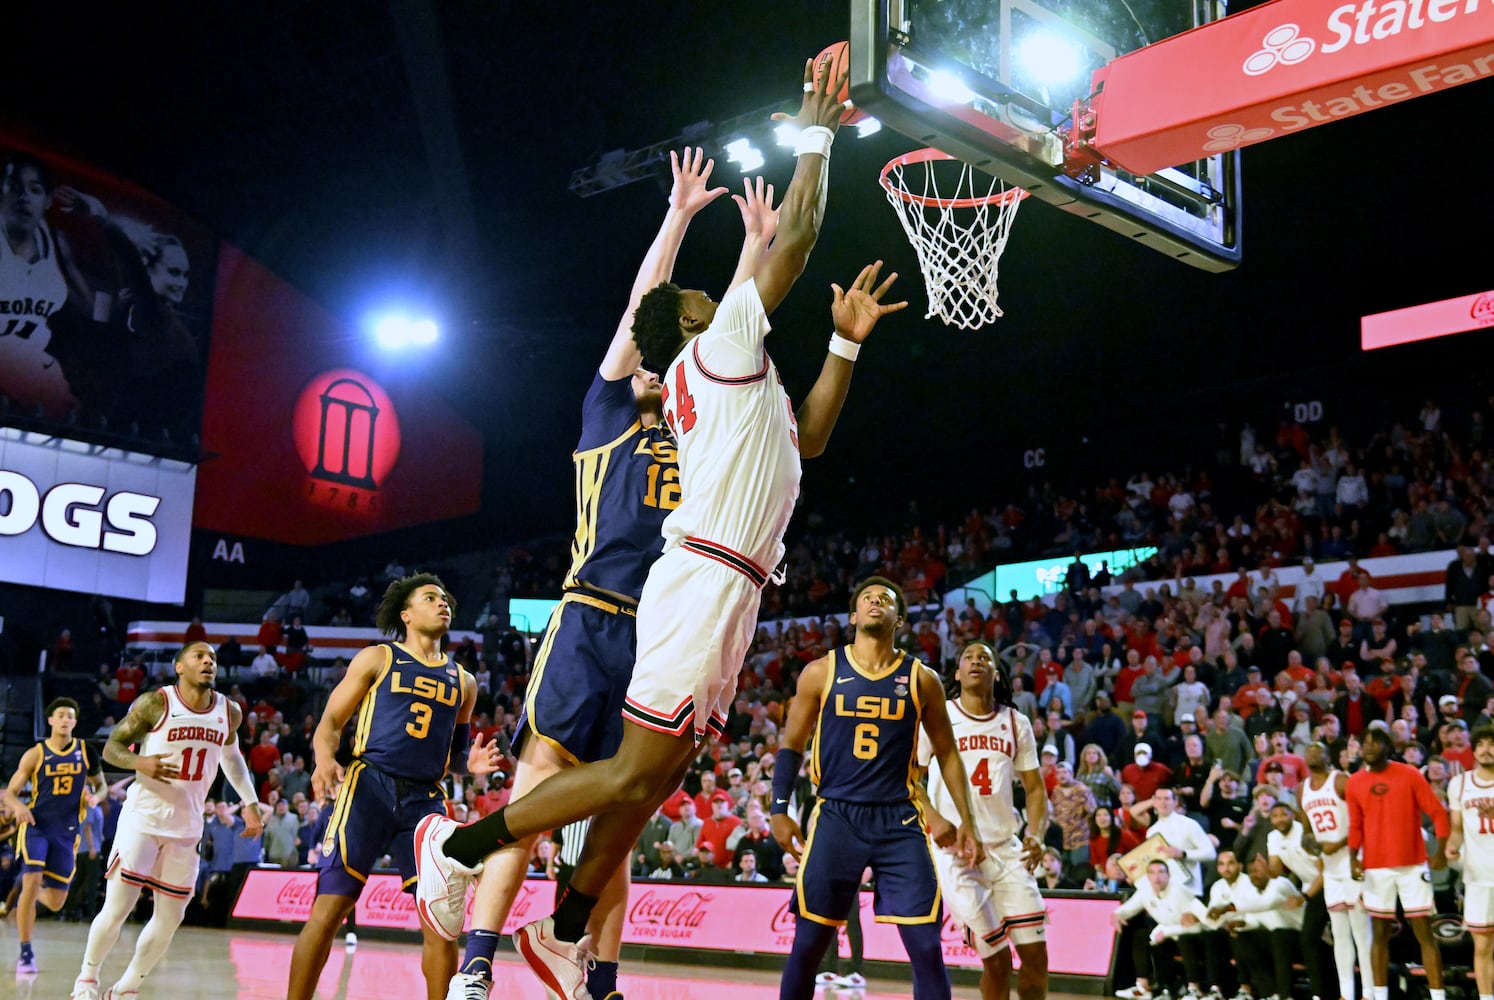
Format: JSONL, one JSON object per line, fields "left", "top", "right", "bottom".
{"left": 565, "top": 372, "right": 680, "bottom": 604}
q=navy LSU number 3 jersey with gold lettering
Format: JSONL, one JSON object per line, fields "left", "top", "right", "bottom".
{"left": 353, "top": 643, "right": 462, "bottom": 783}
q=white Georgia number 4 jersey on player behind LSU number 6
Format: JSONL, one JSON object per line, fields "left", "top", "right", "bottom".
{"left": 919, "top": 698, "right": 1038, "bottom": 846}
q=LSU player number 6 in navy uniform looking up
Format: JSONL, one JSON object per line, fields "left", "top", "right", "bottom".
{"left": 771, "top": 577, "right": 982, "bottom": 1000}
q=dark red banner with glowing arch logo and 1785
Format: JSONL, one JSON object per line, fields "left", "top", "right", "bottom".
{"left": 194, "top": 245, "right": 483, "bottom": 546}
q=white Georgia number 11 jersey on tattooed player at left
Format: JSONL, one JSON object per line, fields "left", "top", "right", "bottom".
{"left": 121, "top": 685, "right": 235, "bottom": 839}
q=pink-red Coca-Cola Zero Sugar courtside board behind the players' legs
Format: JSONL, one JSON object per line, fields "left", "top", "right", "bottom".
{"left": 233, "top": 868, "right": 1119, "bottom": 976}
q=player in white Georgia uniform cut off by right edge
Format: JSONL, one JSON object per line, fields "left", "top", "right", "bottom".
{"left": 1446, "top": 726, "right": 1494, "bottom": 1000}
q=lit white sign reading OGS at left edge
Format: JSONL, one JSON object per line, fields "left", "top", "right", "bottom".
{"left": 0, "top": 428, "right": 197, "bottom": 604}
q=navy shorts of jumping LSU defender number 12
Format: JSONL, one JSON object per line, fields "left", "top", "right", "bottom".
{"left": 514, "top": 592, "right": 638, "bottom": 764}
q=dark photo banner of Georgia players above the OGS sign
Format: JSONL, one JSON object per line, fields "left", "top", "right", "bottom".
{"left": 0, "top": 135, "right": 218, "bottom": 448}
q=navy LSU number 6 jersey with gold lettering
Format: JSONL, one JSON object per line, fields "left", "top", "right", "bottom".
{"left": 810, "top": 646, "right": 923, "bottom": 804}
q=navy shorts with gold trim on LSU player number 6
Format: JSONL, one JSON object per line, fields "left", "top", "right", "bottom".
{"left": 795, "top": 798, "right": 943, "bottom": 927}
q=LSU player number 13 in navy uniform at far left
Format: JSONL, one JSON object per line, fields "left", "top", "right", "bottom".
{"left": 0, "top": 698, "right": 105, "bottom": 973}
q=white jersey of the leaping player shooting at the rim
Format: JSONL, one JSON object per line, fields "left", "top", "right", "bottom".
{"left": 663, "top": 280, "right": 801, "bottom": 572}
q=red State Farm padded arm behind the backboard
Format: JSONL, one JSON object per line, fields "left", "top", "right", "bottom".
{"left": 1092, "top": 0, "right": 1494, "bottom": 173}
